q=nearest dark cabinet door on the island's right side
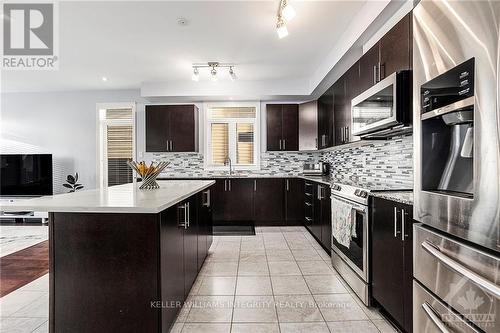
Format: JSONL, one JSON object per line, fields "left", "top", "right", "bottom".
{"left": 160, "top": 206, "right": 185, "bottom": 327}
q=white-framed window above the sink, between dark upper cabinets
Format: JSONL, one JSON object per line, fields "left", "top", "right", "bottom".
{"left": 205, "top": 103, "right": 260, "bottom": 170}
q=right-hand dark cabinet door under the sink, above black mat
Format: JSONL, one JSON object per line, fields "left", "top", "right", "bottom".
{"left": 226, "top": 178, "right": 254, "bottom": 221}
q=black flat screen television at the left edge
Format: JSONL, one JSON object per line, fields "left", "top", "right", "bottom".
{"left": 0, "top": 154, "right": 52, "bottom": 196}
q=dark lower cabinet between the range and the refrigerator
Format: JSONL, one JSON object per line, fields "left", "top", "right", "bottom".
{"left": 370, "top": 198, "right": 413, "bottom": 332}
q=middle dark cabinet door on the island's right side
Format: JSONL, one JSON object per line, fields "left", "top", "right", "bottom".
{"left": 183, "top": 196, "right": 198, "bottom": 297}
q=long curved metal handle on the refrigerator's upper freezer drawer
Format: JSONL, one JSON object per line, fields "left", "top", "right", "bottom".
{"left": 422, "top": 240, "right": 500, "bottom": 298}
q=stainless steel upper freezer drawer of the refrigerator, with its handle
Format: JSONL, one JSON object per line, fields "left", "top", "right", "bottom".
{"left": 413, "top": 225, "right": 500, "bottom": 332}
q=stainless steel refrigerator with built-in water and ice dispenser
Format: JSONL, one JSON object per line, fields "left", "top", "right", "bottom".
{"left": 413, "top": 0, "right": 500, "bottom": 332}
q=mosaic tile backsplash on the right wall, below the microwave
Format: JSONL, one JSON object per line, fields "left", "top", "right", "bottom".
{"left": 321, "top": 135, "right": 413, "bottom": 189}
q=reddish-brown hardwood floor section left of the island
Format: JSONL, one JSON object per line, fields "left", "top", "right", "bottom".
{"left": 0, "top": 241, "right": 49, "bottom": 297}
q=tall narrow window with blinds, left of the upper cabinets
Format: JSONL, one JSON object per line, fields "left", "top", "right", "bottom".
{"left": 98, "top": 105, "right": 134, "bottom": 187}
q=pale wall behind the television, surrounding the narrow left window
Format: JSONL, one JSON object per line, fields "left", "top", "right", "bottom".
{"left": 0, "top": 90, "right": 143, "bottom": 193}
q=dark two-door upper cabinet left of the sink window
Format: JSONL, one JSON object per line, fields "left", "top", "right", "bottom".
{"left": 146, "top": 104, "right": 198, "bottom": 152}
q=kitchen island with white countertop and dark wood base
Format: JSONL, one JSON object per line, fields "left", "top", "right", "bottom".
{"left": 1, "top": 180, "right": 215, "bottom": 332}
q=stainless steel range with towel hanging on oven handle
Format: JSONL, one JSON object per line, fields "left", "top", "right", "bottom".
{"left": 331, "top": 184, "right": 370, "bottom": 305}
